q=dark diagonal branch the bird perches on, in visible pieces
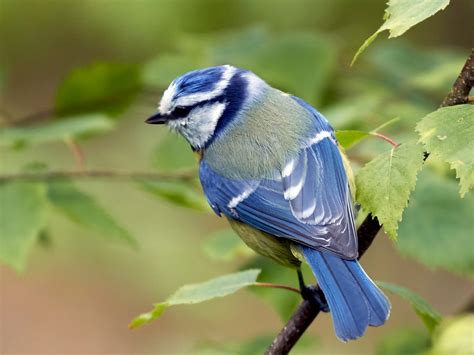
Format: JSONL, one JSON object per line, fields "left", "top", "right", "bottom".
{"left": 265, "top": 49, "right": 474, "bottom": 355}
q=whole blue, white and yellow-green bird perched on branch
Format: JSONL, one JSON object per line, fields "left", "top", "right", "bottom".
{"left": 146, "top": 65, "right": 390, "bottom": 341}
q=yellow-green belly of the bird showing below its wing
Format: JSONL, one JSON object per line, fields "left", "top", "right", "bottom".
{"left": 228, "top": 218, "right": 301, "bottom": 268}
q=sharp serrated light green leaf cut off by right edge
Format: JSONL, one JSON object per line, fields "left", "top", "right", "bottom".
{"left": 416, "top": 105, "right": 474, "bottom": 197}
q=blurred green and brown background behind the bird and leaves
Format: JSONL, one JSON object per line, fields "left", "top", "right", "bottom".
{"left": 0, "top": 0, "right": 474, "bottom": 354}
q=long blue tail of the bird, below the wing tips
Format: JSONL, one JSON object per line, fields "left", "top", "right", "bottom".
{"left": 301, "top": 247, "right": 390, "bottom": 341}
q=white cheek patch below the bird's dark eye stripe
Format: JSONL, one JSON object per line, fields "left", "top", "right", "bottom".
{"left": 168, "top": 102, "right": 226, "bottom": 149}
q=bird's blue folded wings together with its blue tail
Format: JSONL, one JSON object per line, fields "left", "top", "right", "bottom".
{"left": 200, "top": 98, "right": 390, "bottom": 341}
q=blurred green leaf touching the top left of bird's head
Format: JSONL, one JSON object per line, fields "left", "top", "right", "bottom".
{"left": 143, "top": 53, "right": 201, "bottom": 89}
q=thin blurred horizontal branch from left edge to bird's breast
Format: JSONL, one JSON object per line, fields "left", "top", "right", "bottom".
{"left": 0, "top": 170, "right": 196, "bottom": 182}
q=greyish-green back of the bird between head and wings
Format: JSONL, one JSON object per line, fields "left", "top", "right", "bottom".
{"left": 204, "top": 86, "right": 314, "bottom": 179}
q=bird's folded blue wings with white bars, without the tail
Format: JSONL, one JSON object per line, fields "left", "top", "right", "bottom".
{"left": 200, "top": 97, "right": 357, "bottom": 259}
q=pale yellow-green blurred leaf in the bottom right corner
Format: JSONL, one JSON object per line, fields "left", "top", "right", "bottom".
{"left": 428, "top": 314, "right": 474, "bottom": 355}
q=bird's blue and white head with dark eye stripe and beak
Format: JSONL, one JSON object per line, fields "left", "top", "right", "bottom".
{"left": 146, "top": 65, "right": 266, "bottom": 150}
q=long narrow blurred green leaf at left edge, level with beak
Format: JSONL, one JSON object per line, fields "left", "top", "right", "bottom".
{"left": 0, "top": 114, "right": 114, "bottom": 147}
